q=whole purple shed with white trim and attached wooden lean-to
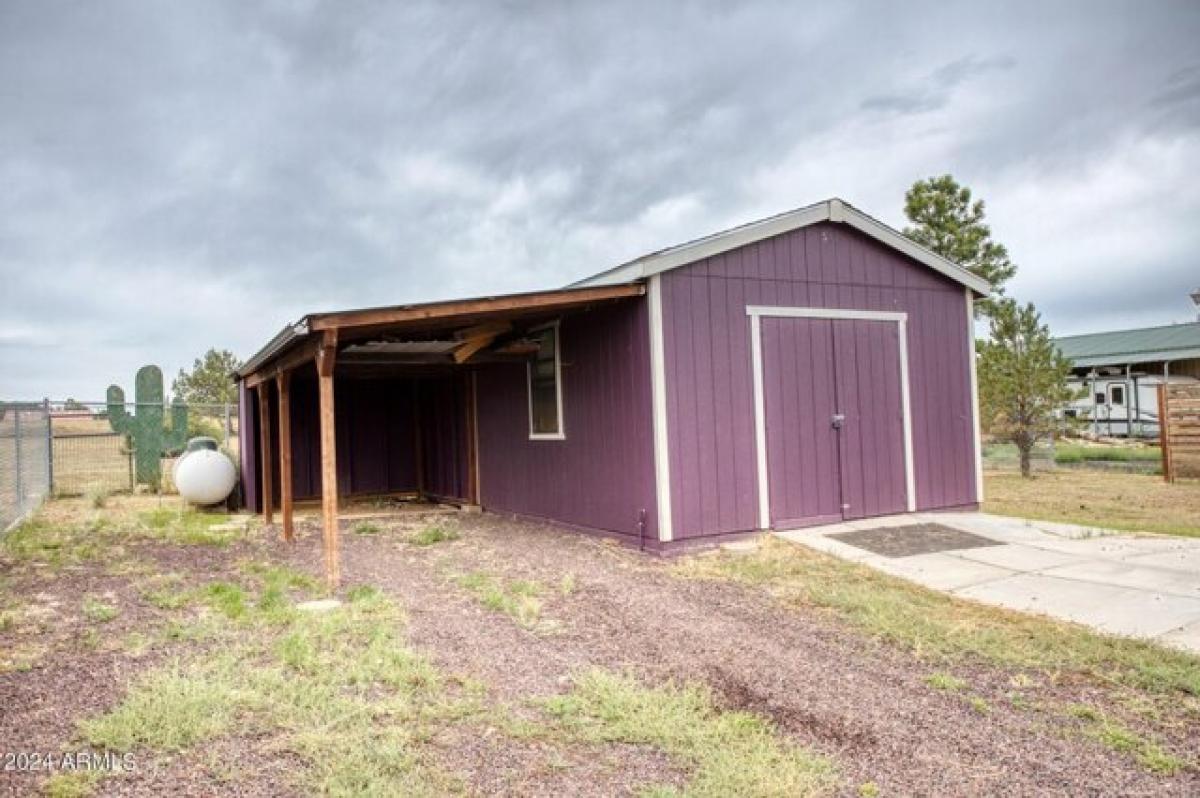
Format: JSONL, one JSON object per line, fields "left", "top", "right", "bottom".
{"left": 239, "top": 199, "right": 989, "bottom": 569}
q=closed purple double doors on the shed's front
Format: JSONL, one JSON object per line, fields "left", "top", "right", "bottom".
{"left": 752, "top": 314, "right": 910, "bottom": 529}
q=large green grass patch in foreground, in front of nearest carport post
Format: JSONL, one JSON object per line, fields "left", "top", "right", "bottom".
{"left": 79, "top": 583, "right": 463, "bottom": 796}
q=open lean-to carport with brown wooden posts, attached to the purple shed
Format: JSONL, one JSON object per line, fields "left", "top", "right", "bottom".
{"left": 238, "top": 283, "right": 644, "bottom": 586}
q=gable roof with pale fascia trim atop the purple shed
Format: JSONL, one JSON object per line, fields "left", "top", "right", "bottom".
{"left": 571, "top": 197, "right": 991, "bottom": 296}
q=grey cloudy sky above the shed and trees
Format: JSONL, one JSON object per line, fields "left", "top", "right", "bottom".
{"left": 0, "top": 0, "right": 1200, "bottom": 400}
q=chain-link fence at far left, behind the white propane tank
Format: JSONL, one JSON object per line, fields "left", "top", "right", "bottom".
{"left": 0, "top": 400, "right": 240, "bottom": 532}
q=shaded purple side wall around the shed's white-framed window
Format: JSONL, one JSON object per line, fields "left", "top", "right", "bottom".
{"left": 476, "top": 299, "right": 658, "bottom": 545}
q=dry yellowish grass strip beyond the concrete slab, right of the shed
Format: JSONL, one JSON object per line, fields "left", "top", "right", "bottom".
{"left": 983, "top": 470, "right": 1200, "bottom": 538}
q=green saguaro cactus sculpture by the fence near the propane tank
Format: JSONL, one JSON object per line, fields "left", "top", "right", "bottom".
{"left": 107, "top": 366, "right": 187, "bottom": 491}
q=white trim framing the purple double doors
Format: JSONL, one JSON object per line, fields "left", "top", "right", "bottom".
{"left": 746, "top": 305, "right": 917, "bottom": 529}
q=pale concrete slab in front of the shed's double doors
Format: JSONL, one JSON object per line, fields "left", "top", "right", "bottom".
{"left": 778, "top": 512, "right": 1200, "bottom": 653}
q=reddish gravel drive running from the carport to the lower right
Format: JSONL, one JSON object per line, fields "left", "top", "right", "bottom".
{"left": 285, "top": 516, "right": 1200, "bottom": 796}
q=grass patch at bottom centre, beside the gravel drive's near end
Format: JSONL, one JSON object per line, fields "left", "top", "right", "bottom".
{"left": 544, "top": 670, "right": 836, "bottom": 797}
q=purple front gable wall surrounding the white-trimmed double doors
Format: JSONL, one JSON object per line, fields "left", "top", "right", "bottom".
{"left": 661, "top": 223, "right": 976, "bottom": 540}
